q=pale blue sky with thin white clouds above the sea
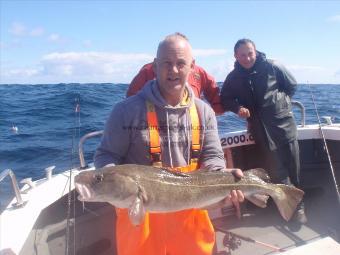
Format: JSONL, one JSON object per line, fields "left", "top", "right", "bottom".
{"left": 0, "top": 0, "right": 340, "bottom": 84}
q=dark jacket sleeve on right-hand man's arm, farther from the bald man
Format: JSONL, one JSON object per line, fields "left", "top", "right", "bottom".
{"left": 273, "top": 61, "right": 297, "bottom": 97}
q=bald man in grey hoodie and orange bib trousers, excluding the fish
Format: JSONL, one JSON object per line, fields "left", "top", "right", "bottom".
{"left": 91, "top": 34, "right": 244, "bottom": 255}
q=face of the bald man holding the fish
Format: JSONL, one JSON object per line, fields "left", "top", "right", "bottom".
{"left": 154, "top": 39, "right": 194, "bottom": 98}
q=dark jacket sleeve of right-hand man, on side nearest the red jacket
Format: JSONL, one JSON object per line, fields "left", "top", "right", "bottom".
{"left": 221, "top": 74, "right": 240, "bottom": 114}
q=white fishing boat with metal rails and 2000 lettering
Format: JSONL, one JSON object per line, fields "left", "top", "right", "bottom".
{"left": 0, "top": 100, "right": 340, "bottom": 255}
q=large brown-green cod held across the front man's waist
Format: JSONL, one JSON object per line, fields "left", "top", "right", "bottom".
{"left": 75, "top": 164, "right": 304, "bottom": 225}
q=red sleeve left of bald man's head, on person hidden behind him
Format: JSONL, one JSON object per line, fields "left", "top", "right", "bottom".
{"left": 126, "top": 63, "right": 155, "bottom": 97}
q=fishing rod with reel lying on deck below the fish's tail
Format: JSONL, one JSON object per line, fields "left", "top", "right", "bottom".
{"left": 214, "top": 226, "right": 285, "bottom": 252}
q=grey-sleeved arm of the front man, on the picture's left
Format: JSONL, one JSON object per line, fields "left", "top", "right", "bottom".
{"left": 94, "top": 103, "right": 130, "bottom": 168}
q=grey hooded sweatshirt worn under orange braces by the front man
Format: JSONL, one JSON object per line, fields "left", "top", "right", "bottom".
{"left": 94, "top": 80, "right": 225, "bottom": 170}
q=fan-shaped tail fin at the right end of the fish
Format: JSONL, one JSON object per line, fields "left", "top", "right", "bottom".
{"left": 270, "top": 184, "right": 304, "bottom": 221}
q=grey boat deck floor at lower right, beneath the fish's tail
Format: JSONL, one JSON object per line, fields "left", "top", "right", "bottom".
{"left": 214, "top": 185, "right": 340, "bottom": 255}
